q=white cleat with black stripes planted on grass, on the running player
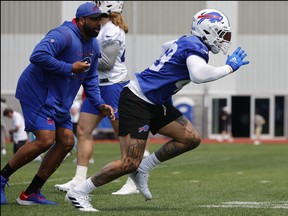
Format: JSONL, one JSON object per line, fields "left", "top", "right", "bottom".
{"left": 65, "top": 189, "right": 99, "bottom": 212}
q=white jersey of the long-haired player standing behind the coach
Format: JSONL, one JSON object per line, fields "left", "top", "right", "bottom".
{"left": 97, "top": 21, "right": 128, "bottom": 86}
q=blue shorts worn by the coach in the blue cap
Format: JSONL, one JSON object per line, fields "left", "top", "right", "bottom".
{"left": 21, "top": 103, "right": 72, "bottom": 132}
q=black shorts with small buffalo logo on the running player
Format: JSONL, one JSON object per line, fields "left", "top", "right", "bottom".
{"left": 118, "top": 87, "right": 183, "bottom": 140}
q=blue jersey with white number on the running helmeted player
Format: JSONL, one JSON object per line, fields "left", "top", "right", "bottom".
{"left": 136, "top": 35, "right": 209, "bottom": 104}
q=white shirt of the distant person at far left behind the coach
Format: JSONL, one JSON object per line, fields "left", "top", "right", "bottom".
{"left": 12, "top": 111, "right": 28, "bottom": 143}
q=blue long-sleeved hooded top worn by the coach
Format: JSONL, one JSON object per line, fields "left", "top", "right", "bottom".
{"left": 16, "top": 21, "right": 105, "bottom": 121}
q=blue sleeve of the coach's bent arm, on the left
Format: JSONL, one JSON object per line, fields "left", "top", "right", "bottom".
{"left": 30, "top": 30, "right": 72, "bottom": 76}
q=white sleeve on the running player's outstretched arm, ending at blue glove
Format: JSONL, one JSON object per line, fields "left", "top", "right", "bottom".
{"left": 186, "top": 55, "right": 231, "bottom": 84}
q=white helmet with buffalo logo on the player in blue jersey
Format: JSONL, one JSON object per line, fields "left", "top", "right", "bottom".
{"left": 191, "top": 9, "right": 232, "bottom": 55}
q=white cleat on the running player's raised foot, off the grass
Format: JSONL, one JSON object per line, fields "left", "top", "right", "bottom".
{"left": 129, "top": 170, "right": 152, "bottom": 200}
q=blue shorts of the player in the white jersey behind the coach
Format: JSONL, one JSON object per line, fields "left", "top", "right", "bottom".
{"left": 80, "top": 82, "right": 128, "bottom": 119}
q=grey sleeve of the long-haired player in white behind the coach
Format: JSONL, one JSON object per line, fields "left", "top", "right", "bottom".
{"left": 98, "top": 41, "right": 120, "bottom": 71}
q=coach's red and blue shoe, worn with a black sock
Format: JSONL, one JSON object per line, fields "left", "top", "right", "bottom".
{"left": 16, "top": 189, "right": 57, "bottom": 205}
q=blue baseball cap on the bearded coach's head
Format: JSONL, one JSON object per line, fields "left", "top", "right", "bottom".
{"left": 76, "top": 2, "right": 108, "bottom": 18}
